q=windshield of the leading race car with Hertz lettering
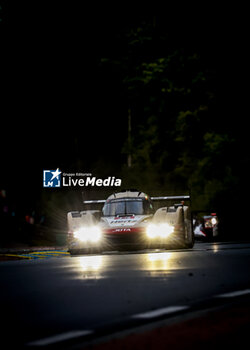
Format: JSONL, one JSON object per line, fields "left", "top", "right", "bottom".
{"left": 103, "top": 198, "right": 153, "bottom": 216}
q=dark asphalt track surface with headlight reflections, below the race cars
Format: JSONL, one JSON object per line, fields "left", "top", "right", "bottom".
{"left": 0, "top": 242, "right": 250, "bottom": 349}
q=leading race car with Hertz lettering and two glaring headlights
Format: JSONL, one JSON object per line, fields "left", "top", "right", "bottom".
{"left": 67, "top": 190, "right": 194, "bottom": 254}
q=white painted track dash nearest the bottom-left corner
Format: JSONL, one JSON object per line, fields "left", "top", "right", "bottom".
{"left": 27, "top": 330, "right": 93, "bottom": 346}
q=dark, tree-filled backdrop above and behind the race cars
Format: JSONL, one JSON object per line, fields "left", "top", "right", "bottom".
{"left": 0, "top": 1, "right": 250, "bottom": 241}
